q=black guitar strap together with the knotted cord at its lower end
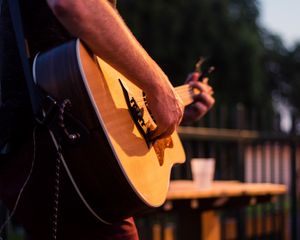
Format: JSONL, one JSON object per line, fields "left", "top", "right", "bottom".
{"left": 7, "top": 0, "right": 88, "bottom": 143}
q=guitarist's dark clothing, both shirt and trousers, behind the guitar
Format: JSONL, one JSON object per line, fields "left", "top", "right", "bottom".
{"left": 0, "top": 0, "right": 138, "bottom": 240}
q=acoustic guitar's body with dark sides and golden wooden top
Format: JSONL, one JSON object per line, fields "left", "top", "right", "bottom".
{"left": 33, "top": 40, "right": 185, "bottom": 222}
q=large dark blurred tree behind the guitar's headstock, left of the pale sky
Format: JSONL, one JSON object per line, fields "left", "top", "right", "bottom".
{"left": 119, "top": 0, "right": 271, "bottom": 111}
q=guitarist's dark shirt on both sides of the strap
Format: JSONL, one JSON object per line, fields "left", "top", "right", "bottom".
{"left": 0, "top": 0, "right": 72, "bottom": 149}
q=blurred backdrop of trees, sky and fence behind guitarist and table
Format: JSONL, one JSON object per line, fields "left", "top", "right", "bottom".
{"left": 0, "top": 0, "right": 300, "bottom": 240}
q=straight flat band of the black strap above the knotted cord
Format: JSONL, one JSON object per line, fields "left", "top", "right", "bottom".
{"left": 7, "top": 0, "right": 41, "bottom": 116}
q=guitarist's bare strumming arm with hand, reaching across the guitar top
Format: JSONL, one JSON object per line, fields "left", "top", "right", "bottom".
{"left": 47, "top": 0, "right": 183, "bottom": 137}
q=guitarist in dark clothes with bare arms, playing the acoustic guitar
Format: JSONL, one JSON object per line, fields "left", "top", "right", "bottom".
{"left": 0, "top": 0, "right": 214, "bottom": 240}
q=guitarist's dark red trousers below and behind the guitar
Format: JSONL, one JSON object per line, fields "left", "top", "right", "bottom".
{"left": 0, "top": 129, "right": 138, "bottom": 240}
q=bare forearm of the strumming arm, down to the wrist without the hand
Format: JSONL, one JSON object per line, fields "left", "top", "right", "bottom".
{"left": 47, "top": 0, "right": 168, "bottom": 94}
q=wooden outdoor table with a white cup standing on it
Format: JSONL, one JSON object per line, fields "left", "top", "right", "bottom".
{"left": 161, "top": 180, "right": 287, "bottom": 240}
